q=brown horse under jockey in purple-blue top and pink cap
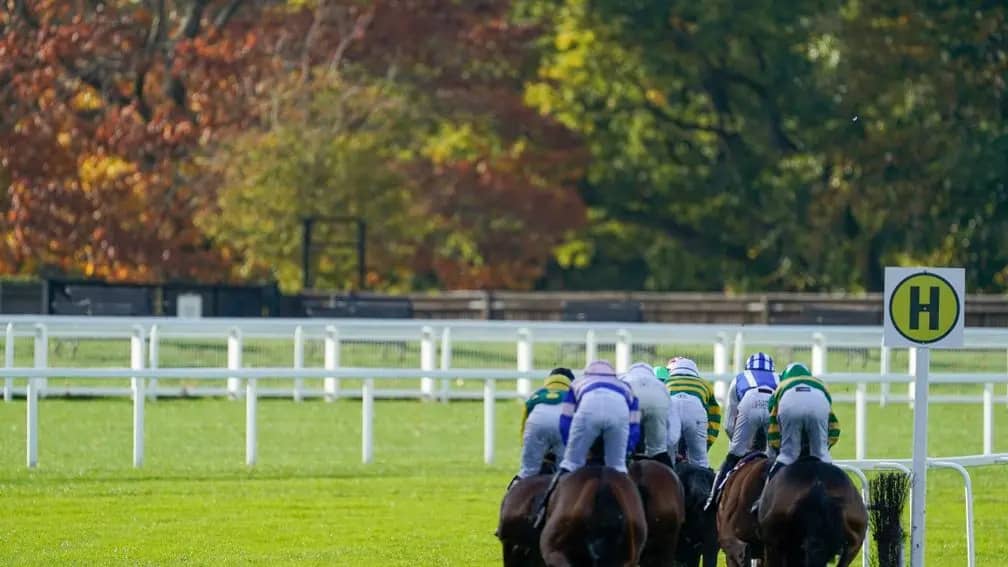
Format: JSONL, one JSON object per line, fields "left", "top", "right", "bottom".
{"left": 539, "top": 466, "right": 647, "bottom": 567}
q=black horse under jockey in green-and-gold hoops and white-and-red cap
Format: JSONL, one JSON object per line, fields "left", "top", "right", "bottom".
{"left": 675, "top": 461, "right": 721, "bottom": 567}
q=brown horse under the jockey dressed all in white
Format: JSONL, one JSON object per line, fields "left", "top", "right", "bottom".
{"left": 629, "top": 459, "right": 685, "bottom": 567}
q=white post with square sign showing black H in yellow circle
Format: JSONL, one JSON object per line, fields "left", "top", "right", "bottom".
{"left": 882, "top": 267, "right": 966, "bottom": 567}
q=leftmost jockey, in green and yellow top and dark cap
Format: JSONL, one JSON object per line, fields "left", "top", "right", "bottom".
{"left": 508, "top": 368, "right": 574, "bottom": 489}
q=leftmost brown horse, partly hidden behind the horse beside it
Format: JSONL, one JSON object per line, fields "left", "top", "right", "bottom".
{"left": 495, "top": 474, "right": 551, "bottom": 567}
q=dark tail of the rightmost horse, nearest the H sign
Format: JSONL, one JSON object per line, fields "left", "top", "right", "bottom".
{"left": 795, "top": 479, "right": 845, "bottom": 567}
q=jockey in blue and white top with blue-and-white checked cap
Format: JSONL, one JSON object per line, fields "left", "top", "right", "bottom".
{"left": 707, "top": 352, "right": 777, "bottom": 506}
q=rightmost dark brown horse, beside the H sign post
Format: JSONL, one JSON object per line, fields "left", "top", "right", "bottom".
{"left": 759, "top": 457, "right": 868, "bottom": 567}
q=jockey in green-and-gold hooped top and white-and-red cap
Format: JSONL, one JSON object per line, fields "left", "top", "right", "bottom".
{"left": 665, "top": 357, "right": 721, "bottom": 468}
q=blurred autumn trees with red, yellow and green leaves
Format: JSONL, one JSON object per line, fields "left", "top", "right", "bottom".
{"left": 0, "top": 0, "right": 1008, "bottom": 292}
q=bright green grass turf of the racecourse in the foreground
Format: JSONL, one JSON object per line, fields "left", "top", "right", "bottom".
{"left": 0, "top": 400, "right": 1008, "bottom": 567}
